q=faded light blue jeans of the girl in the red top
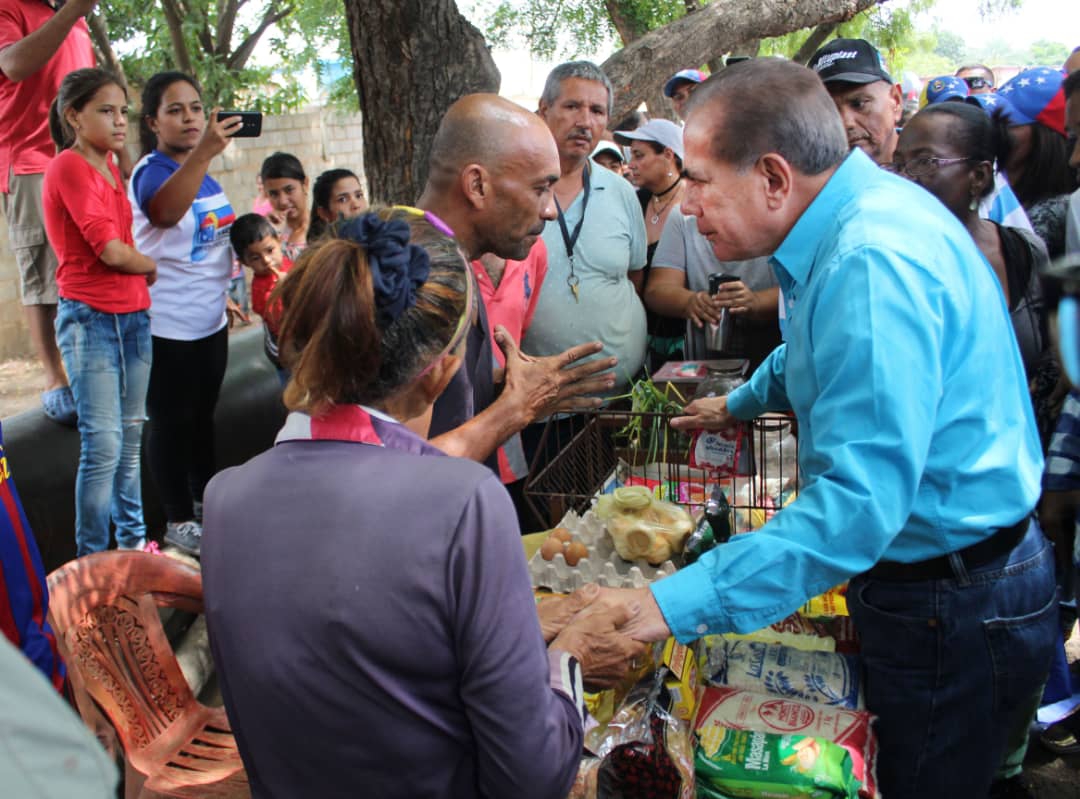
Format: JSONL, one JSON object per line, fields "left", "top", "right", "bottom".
{"left": 56, "top": 297, "right": 151, "bottom": 557}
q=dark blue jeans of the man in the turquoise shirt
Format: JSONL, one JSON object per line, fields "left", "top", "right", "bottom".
{"left": 848, "top": 522, "right": 1057, "bottom": 799}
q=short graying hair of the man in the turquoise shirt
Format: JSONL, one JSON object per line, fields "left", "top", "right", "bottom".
{"left": 688, "top": 58, "right": 850, "bottom": 175}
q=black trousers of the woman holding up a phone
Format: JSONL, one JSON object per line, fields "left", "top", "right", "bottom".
{"left": 146, "top": 327, "right": 229, "bottom": 522}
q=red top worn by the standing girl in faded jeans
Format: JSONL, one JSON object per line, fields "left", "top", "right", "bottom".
{"left": 41, "top": 150, "right": 150, "bottom": 313}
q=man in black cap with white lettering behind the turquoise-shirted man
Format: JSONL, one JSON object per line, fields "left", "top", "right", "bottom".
{"left": 807, "top": 39, "right": 904, "bottom": 164}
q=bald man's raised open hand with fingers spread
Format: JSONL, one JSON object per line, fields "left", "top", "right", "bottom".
{"left": 495, "top": 325, "right": 618, "bottom": 422}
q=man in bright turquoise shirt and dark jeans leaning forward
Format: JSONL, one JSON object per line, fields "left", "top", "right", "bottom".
{"left": 622, "top": 59, "right": 1057, "bottom": 799}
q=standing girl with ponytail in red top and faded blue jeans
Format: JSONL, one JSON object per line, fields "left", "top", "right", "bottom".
{"left": 42, "top": 69, "right": 157, "bottom": 556}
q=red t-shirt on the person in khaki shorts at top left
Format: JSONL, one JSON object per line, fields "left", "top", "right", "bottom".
{"left": 0, "top": 0, "right": 94, "bottom": 194}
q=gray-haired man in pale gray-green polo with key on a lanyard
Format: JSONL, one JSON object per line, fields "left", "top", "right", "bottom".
{"left": 522, "top": 62, "right": 646, "bottom": 393}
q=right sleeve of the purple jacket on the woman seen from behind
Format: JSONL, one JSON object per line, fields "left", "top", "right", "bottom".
{"left": 447, "top": 475, "right": 584, "bottom": 799}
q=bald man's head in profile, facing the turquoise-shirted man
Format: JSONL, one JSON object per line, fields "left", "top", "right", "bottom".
{"left": 420, "top": 94, "right": 559, "bottom": 260}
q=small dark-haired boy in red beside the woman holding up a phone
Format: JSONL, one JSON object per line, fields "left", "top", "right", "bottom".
{"left": 229, "top": 214, "right": 293, "bottom": 385}
